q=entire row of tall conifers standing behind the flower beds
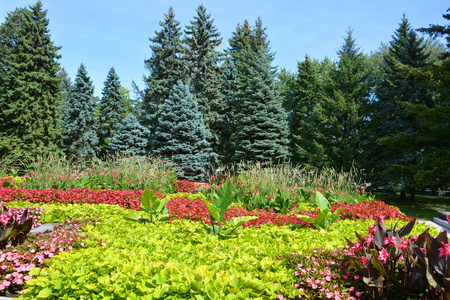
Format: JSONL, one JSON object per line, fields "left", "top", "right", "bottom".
{"left": 0, "top": 1, "right": 450, "bottom": 196}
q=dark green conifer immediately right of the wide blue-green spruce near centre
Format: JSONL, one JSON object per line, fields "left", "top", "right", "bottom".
{"left": 287, "top": 55, "right": 327, "bottom": 167}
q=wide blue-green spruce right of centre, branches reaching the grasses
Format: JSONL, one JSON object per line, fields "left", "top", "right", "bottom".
{"left": 233, "top": 48, "right": 289, "bottom": 164}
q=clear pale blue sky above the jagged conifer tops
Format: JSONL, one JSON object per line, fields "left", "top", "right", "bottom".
{"left": 0, "top": 0, "right": 450, "bottom": 95}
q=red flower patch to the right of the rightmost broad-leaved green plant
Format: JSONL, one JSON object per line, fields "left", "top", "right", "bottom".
{"left": 331, "top": 200, "right": 408, "bottom": 220}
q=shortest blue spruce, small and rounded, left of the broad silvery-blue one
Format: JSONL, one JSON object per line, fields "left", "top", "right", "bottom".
{"left": 109, "top": 114, "right": 150, "bottom": 155}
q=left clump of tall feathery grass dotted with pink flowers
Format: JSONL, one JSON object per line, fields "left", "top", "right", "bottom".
{"left": 14, "top": 156, "right": 176, "bottom": 193}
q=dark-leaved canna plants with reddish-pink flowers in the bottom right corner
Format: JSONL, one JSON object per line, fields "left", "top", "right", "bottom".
{"left": 347, "top": 218, "right": 450, "bottom": 300}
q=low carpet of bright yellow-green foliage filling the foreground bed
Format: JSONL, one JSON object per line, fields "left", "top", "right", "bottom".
{"left": 10, "top": 204, "right": 438, "bottom": 299}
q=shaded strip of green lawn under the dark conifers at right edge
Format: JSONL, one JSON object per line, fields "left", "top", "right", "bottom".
{"left": 375, "top": 193, "right": 450, "bottom": 221}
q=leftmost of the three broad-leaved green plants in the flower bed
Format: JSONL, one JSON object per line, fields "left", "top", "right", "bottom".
{"left": 125, "top": 190, "right": 176, "bottom": 223}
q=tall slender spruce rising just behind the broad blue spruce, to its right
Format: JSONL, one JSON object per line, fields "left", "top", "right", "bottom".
{"left": 184, "top": 5, "right": 228, "bottom": 163}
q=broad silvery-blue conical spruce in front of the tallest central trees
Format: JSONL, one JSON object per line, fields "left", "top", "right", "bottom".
{"left": 153, "top": 81, "right": 209, "bottom": 181}
